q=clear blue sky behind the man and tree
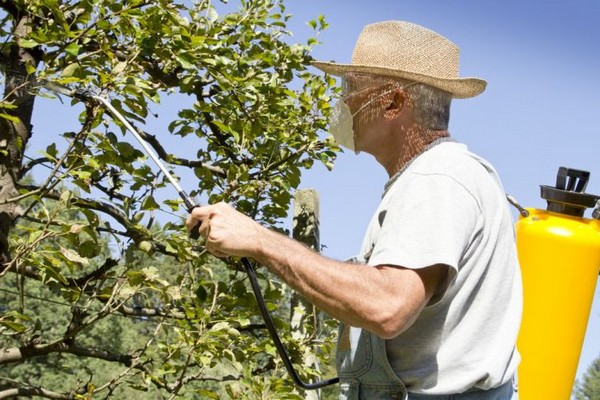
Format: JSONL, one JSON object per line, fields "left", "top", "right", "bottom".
{"left": 34, "top": 0, "right": 600, "bottom": 386}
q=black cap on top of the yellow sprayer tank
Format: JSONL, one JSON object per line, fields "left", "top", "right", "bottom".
{"left": 540, "top": 167, "right": 600, "bottom": 217}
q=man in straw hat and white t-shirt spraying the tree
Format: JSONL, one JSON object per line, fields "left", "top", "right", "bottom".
{"left": 187, "top": 21, "right": 522, "bottom": 400}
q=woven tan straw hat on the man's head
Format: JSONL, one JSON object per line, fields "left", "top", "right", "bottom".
{"left": 313, "top": 21, "right": 487, "bottom": 98}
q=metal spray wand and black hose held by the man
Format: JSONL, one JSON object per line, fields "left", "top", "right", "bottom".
{"left": 38, "top": 81, "right": 339, "bottom": 390}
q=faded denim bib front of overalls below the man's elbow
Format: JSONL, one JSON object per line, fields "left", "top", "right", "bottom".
{"left": 336, "top": 324, "right": 407, "bottom": 400}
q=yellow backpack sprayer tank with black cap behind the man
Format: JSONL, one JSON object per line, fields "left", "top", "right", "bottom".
{"left": 516, "top": 167, "right": 600, "bottom": 400}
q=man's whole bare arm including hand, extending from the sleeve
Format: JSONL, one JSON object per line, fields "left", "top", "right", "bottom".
{"left": 187, "top": 203, "right": 447, "bottom": 338}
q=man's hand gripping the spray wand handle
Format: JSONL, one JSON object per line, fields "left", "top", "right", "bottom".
{"left": 185, "top": 203, "right": 265, "bottom": 257}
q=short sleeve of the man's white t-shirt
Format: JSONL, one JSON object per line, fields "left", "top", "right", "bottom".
{"left": 369, "top": 174, "right": 481, "bottom": 305}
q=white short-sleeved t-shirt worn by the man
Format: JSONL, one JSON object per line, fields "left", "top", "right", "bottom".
{"left": 362, "top": 142, "right": 522, "bottom": 394}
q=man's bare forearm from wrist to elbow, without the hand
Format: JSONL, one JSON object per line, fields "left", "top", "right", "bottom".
{"left": 252, "top": 228, "right": 422, "bottom": 337}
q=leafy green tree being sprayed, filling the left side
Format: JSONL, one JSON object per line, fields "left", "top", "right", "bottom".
{"left": 0, "top": 0, "right": 338, "bottom": 399}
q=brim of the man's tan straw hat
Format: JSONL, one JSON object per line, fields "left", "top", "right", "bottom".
{"left": 312, "top": 61, "right": 487, "bottom": 99}
